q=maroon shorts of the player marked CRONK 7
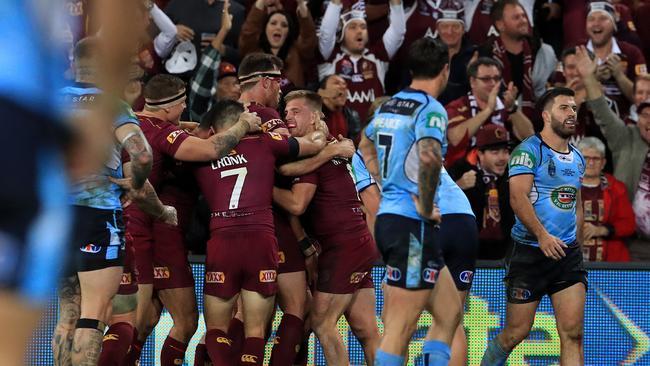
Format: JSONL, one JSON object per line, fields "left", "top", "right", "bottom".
{"left": 205, "top": 229, "right": 278, "bottom": 299}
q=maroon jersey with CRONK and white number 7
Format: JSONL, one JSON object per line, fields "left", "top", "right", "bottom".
{"left": 194, "top": 132, "right": 298, "bottom": 232}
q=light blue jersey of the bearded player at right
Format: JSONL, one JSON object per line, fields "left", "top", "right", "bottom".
{"left": 508, "top": 135, "right": 585, "bottom": 246}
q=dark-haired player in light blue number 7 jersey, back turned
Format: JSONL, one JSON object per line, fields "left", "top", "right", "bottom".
{"left": 359, "top": 38, "right": 461, "bottom": 365}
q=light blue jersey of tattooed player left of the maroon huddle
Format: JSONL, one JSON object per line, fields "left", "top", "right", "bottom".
{"left": 61, "top": 86, "right": 140, "bottom": 210}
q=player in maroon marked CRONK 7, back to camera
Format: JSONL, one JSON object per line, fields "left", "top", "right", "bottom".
{"left": 194, "top": 100, "right": 325, "bottom": 366}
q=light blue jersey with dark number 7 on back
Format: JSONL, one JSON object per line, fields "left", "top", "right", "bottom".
{"left": 365, "top": 88, "right": 448, "bottom": 220}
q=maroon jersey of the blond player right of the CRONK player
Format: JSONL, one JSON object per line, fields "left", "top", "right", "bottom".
{"left": 294, "top": 152, "right": 368, "bottom": 245}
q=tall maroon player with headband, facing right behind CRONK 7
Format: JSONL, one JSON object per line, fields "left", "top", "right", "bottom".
{"left": 233, "top": 53, "right": 354, "bottom": 365}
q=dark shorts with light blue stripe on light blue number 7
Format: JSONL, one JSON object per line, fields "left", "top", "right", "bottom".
{"left": 375, "top": 214, "right": 445, "bottom": 290}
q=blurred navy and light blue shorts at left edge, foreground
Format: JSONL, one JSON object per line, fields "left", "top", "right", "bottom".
{"left": 0, "top": 99, "right": 72, "bottom": 304}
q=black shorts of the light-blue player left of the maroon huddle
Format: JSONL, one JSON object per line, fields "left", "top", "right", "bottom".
{"left": 68, "top": 206, "right": 125, "bottom": 275}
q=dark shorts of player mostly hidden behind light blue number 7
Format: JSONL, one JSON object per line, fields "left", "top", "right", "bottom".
{"left": 440, "top": 214, "right": 478, "bottom": 291}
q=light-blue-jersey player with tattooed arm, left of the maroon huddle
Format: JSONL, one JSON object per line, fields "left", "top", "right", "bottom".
{"left": 52, "top": 37, "right": 154, "bottom": 365}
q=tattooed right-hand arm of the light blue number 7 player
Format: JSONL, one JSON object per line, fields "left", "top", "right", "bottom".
{"left": 416, "top": 138, "right": 442, "bottom": 218}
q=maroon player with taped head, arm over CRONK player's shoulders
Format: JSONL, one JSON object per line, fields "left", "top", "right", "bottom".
{"left": 116, "top": 75, "right": 260, "bottom": 365}
